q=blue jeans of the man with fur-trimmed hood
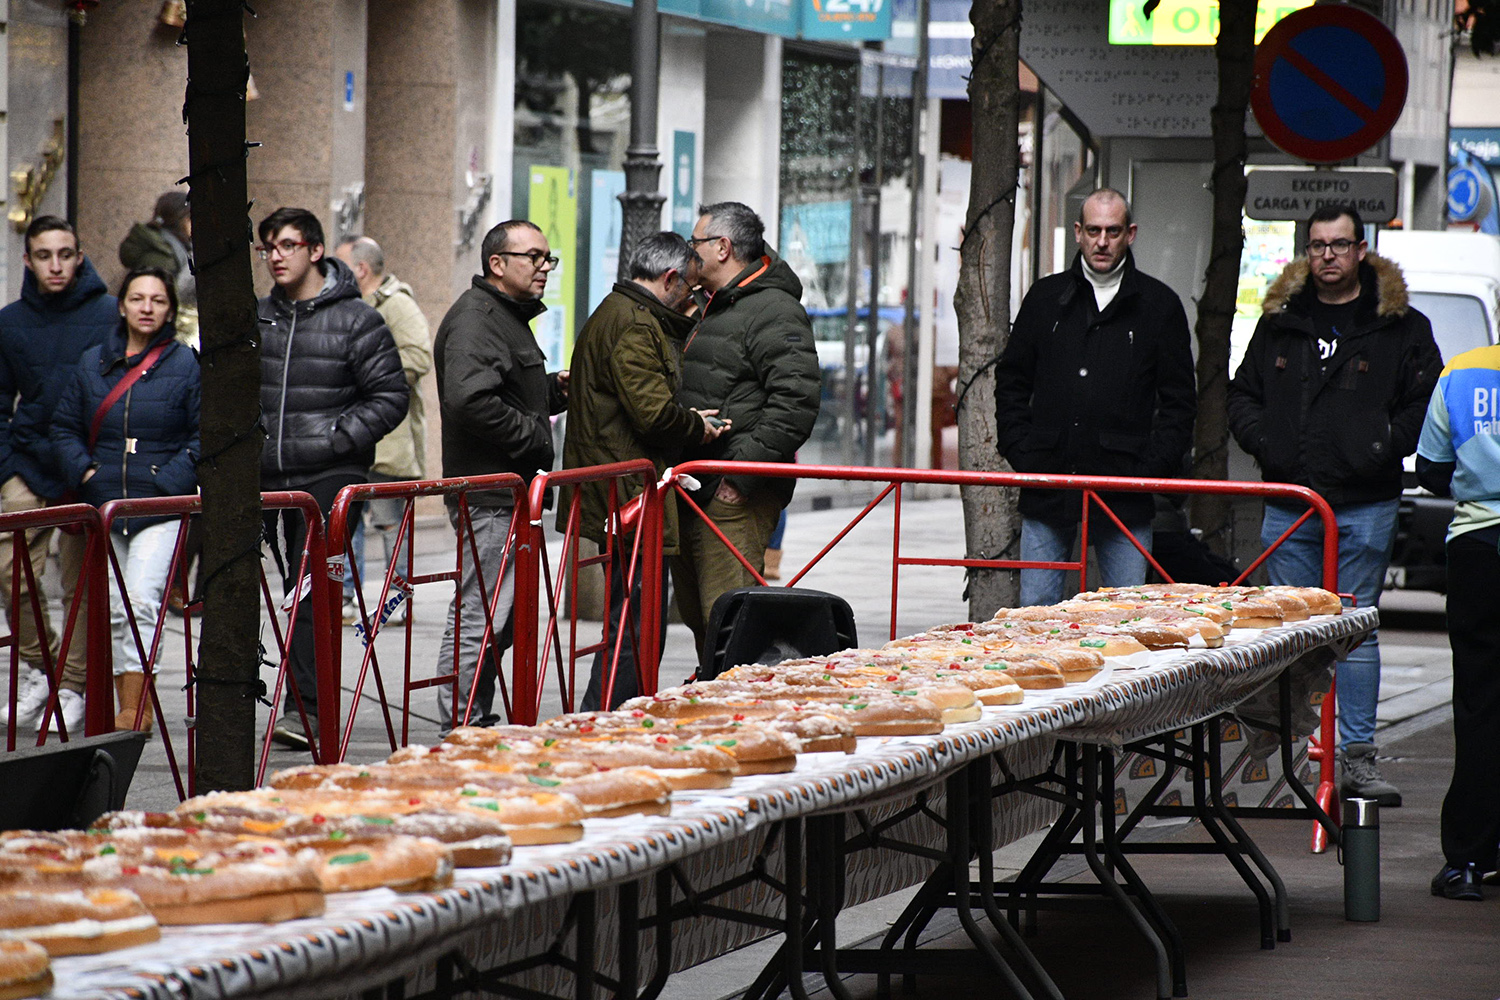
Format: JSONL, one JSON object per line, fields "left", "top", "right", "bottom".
{"left": 1260, "top": 499, "right": 1401, "bottom": 747}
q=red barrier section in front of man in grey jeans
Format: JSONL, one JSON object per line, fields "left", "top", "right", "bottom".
{"left": 330, "top": 474, "right": 537, "bottom": 760}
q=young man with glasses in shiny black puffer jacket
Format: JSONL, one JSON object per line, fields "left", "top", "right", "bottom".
{"left": 260, "top": 208, "right": 408, "bottom": 748}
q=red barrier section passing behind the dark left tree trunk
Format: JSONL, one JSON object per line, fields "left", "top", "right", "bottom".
{"left": 90, "top": 492, "right": 339, "bottom": 798}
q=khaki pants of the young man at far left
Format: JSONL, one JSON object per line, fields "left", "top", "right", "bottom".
{"left": 0, "top": 475, "right": 89, "bottom": 694}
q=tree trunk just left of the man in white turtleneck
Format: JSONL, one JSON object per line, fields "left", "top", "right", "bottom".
{"left": 954, "top": 0, "right": 1022, "bottom": 618}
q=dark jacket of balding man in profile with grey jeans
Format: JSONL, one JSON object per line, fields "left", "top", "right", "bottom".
{"left": 432, "top": 276, "right": 567, "bottom": 507}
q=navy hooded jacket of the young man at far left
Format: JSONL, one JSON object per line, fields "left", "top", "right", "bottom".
{"left": 0, "top": 258, "right": 120, "bottom": 499}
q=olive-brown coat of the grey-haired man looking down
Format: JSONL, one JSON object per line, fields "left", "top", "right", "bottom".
{"left": 558, "top": 282, "right": 704, "bottom": 555}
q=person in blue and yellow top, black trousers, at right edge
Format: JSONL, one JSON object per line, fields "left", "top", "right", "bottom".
{"left": 1416, "top": 346, "right": 1500, "bottom": 900}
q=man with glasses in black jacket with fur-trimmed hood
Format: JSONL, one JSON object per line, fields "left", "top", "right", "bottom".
{"left": 1229, "top": 205, "right": 1443, "bottom": 805}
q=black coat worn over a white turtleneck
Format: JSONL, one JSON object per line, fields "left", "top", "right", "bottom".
{"left": 995, "top": 252, "right": 1197, "bottom": 526}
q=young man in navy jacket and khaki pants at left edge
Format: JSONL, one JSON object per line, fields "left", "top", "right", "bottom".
{"left": 0, "top": 216, "right": 120, "bottom": 735}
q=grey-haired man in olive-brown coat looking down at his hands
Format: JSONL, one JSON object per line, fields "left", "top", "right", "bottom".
{"left": 558, "top": 232, "right": 723, "bottom": 712}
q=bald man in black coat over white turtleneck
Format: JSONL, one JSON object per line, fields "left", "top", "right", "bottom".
{"left": 995, "top": 187, "right": 1197, "bottom": 604}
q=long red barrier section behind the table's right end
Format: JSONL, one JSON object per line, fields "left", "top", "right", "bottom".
{"left": 657, "top": 462, "right": 1338, "bottom": 853}
